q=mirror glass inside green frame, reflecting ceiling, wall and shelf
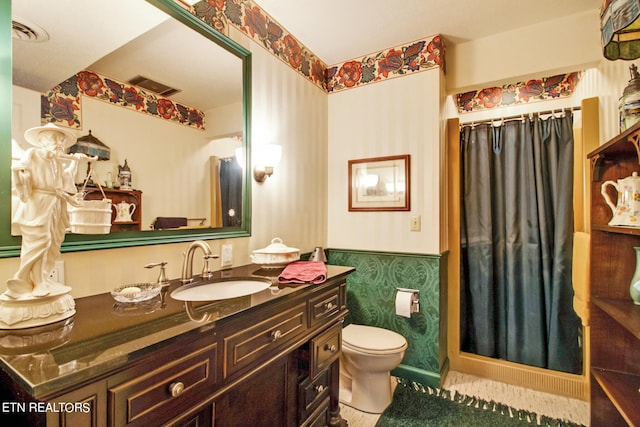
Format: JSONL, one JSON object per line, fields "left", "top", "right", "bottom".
{"left": 12, "top": 0, "right": 246, "bottom": 246}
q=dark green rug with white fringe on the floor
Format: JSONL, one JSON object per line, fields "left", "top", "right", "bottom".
{"left": 376, "top": 380, "right": 581, "bottom": 427}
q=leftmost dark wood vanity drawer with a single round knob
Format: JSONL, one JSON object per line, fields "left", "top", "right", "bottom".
{"left": 108, "top": 343, "right": 217, "bottom": 427}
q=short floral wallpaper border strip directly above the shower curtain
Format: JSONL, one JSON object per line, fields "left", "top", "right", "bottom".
{"left": 455, "top": 71, "right": 583, "bottom": 113}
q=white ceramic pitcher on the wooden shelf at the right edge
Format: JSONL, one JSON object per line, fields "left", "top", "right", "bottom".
{"left": 600, "top": 172, "right": 640, "bottom": 227}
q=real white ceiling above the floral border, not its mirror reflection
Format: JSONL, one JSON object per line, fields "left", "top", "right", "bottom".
{"left": 256, "top": 0, "right": 602, "bottom": 65}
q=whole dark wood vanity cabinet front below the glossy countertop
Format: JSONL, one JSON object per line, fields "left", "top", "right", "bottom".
{"left": 0, "top": 267, "right": 351, "bottom": 427}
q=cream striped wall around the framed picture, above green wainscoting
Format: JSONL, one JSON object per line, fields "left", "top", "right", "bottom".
{"left": 327, "top": 68, "right": 442, "bottom": 254}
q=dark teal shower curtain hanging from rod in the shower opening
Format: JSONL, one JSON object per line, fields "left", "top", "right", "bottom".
{"left": 460, "top": 113, "right": 582, "bottom": 373}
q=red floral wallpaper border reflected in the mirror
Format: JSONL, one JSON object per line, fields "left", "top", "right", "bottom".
{"left": 40, "top": 70, "right": 205, "bottom": 130}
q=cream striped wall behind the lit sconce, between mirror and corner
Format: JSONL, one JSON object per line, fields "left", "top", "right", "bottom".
{"left": 249, "top": 43, "right": 333, "bottom": 252}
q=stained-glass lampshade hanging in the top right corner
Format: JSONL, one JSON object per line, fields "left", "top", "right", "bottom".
{"left": 600, "top": 0, "right": 640, "bottom": 60}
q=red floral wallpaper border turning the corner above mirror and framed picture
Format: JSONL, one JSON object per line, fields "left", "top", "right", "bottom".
{"left": 185, "top": 0, "right": 444, "bottom": 93}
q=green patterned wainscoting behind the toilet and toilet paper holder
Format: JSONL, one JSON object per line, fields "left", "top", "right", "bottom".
{"left": 327, "top": 249, "right": 446, "bottom": 387}
